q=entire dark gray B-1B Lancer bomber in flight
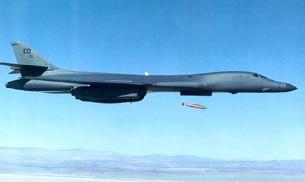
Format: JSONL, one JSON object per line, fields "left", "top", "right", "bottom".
{"left": 0, "top": 41, "right": 297, "bottom": 103}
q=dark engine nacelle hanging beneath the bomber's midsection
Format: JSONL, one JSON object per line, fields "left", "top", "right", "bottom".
{"left": 71, "top": 86, "right": 146, "bottom": 103}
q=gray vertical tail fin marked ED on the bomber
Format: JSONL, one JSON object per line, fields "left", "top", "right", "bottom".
{"left": 11, "top": 41, "right": 57, "bottom": 69}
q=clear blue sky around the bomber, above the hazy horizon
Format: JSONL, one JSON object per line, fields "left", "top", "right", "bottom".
{"left": 0, "top": 0, "right": 305, "bottom": 160}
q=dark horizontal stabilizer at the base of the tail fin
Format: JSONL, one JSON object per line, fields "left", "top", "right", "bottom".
{"left": 0, "top": 62, "right": 48, "bottom": 77}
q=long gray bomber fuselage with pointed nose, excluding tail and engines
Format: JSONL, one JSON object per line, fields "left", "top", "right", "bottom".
{"left": 6, "top": 70, "right": 296, "bottom": 93}
